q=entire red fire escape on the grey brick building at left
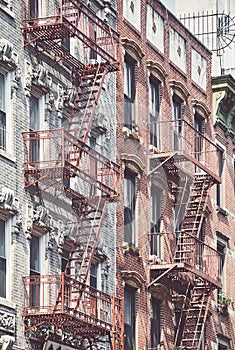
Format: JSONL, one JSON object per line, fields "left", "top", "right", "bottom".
{"left": 22, "top": 0, "right": 123, "bottom": 350}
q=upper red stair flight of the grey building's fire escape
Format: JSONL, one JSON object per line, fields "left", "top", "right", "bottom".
{"left": 67, "top": 64, "right": 107, "bottom": 146}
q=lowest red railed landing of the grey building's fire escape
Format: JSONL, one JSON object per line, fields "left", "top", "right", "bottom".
{"left": 23, "top": 273, "right": 122, "bottom": 336}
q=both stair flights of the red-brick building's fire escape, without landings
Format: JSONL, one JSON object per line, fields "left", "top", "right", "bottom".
{"left": 174, "top": 174, "right": 218, "bottom": 350}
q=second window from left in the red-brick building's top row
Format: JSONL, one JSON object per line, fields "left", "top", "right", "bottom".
{"left": 150, "top": 78, "right": 160, "bottom": 148}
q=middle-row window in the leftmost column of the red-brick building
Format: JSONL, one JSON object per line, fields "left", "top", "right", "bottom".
{"left": 124, "top": 169, "right": 136, "bottom": 244}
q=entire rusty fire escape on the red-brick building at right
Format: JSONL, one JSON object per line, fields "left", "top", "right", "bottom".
{"left": 149, "top": 120, "right": 221, "bottom": 350}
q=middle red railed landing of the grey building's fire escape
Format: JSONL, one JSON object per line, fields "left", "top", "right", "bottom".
{"left": 23, "top": 129, "right": 120, "bottom": 199}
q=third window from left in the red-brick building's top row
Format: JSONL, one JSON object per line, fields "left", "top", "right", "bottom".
{"left": 173, "top": 97, "right": 182, "bottom": 151}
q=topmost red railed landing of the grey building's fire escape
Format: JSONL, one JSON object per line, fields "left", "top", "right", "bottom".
{"left": 22, "top": 0, "right": 120, "bottom": 71}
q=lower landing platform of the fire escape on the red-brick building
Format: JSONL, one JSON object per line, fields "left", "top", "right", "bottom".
{"left": 150, "top": 262, "right": 222, "bottom": 288}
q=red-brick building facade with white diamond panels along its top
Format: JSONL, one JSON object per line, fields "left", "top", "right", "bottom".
{"left": 117, "top": 1, "right": 234, "bottom": 349}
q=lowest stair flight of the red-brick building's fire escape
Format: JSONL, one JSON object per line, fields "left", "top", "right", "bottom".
{"left": 180, "top": 278, "right": 213, "bottom": 350}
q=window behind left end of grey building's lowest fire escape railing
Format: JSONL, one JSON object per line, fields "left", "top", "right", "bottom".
{"left": 30, "top": 236, "right": 40, "bottom": 306}
